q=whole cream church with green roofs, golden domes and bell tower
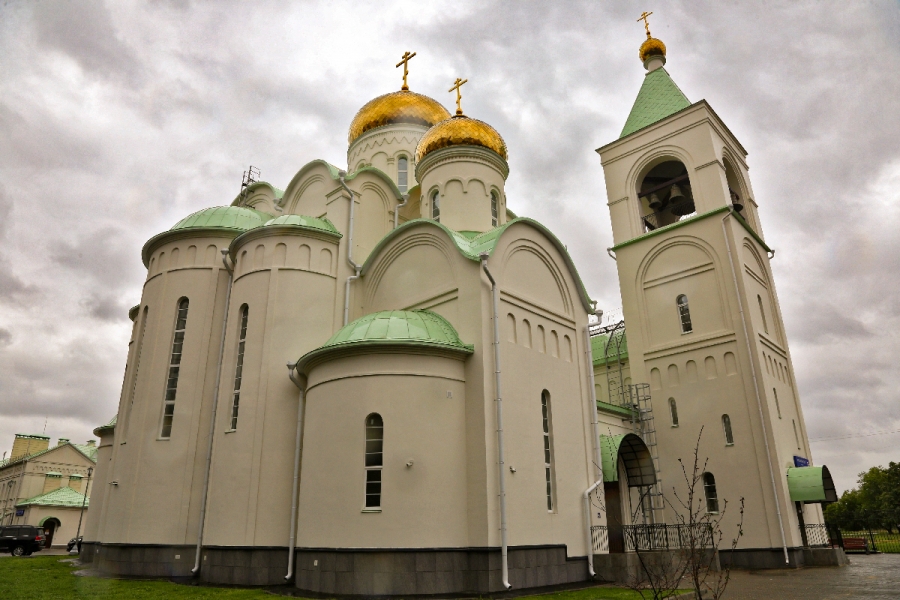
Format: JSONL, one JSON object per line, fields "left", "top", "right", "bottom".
{"left": 82, "top": 23, "right": 835, "bottom": 596}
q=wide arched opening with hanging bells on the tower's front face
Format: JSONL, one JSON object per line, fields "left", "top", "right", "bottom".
{"left": 638, "top": 160, "right": 697, "bottom": 232}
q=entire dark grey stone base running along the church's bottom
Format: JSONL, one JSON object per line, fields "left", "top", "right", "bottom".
{"left": 81, "top": 542, "right": 590, "bottom": 596}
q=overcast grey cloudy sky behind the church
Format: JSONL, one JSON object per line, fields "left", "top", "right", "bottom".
{"left": 0, "top": 0, "right": 900, "bottom": 489}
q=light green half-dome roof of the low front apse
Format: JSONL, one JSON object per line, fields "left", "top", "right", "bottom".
{"left": 297, "top": 310, "right": 474, "bottom": 370}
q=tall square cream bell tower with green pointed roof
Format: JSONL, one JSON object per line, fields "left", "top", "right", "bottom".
{"left": 597, "top": 22, "right": 833, "bottom": 567}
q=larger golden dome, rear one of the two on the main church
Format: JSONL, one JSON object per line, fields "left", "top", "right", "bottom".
{"left": 347, "top": 90, "right": 450, "bottom": 144}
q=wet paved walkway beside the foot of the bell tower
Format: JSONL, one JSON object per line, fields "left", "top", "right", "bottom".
{"left": 725, "top": 554, "right": 900, "bottom": 600}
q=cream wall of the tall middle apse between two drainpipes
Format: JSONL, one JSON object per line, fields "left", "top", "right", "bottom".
{"left": 207, "top": 228, "right": 337, "bottom": 546}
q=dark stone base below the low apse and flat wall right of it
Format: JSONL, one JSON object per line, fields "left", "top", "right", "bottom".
{"left": 296, "top": 546, "right": 590, "bottom": 596}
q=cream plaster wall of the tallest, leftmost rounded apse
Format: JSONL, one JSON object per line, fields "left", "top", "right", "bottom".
{"left": 101, "top": 234, "right": 228, "bottom": 544}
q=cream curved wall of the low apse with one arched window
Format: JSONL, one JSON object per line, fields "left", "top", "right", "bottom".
{"left": 298, "top": 353, "right": 470, "bottom": 548}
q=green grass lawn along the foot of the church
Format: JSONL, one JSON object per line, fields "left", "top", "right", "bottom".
{"left": 0, "top": 556, "right": 660, "bottom": 600}
